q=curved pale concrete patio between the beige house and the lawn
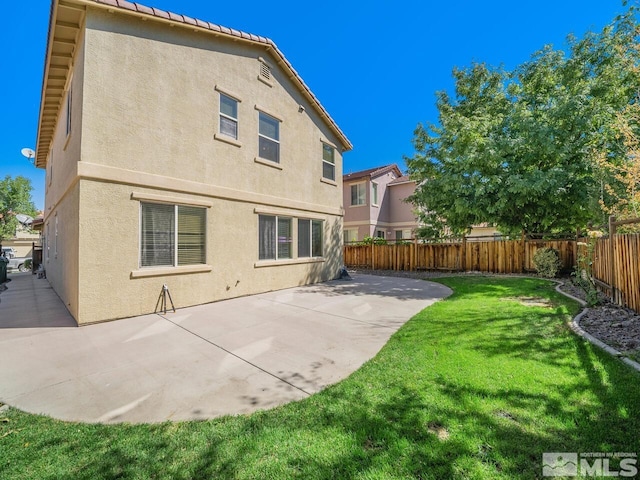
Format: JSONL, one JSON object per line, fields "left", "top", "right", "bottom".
{"left": 0, "top": 274, "right": 451, "bottom": 423}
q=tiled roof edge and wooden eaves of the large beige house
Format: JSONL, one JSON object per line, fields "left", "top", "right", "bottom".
{"left": 35, "top": 0, "right": 353, "bottom": 168}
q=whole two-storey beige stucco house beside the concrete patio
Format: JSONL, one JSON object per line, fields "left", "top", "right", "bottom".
{"left": 36, "top": 0, "right": 351, "bottom": 324}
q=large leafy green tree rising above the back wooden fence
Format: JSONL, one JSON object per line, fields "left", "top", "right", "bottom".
{"left": 406, "top": 8, "right": 640, "bottom": 237}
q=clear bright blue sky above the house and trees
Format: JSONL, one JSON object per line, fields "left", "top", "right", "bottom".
{"left": 0, "top": 0, "right": 626, "bottom": 208}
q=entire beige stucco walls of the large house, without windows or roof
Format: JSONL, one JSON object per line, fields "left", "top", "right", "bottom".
{"left": 45, "top": 8, "right": 343, "bottom": 324}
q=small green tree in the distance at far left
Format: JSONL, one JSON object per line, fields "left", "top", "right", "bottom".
{"left": 0, "top": 175, "right": 37, "bottom": 242}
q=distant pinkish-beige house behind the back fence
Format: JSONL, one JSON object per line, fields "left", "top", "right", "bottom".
{"left": 342, "top": 164, "right": 418, "bottom": 244}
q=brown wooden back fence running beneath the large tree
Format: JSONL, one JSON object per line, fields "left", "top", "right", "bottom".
{"left": 344, "top": 239, "right": 577, "bottom": 273}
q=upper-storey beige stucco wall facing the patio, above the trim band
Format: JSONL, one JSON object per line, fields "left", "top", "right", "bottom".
{"left": 83, "top": 9, "right": 342, "bottom": 204}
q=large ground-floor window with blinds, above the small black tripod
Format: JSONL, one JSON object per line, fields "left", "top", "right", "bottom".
{"left": 140, "top": 202, "right": 207, "bottom": 267}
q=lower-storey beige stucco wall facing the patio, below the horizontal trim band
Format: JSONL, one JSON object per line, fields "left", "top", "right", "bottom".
{"left": 77, "top": 180, "right": 342, "bottom": 323}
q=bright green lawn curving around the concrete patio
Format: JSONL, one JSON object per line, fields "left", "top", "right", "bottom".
{"left": 0, "top": 277, "right": 640, "bottom": 480}
